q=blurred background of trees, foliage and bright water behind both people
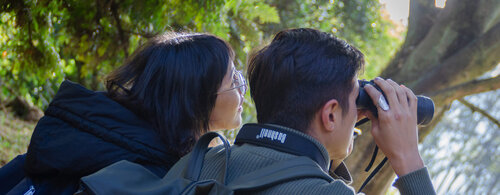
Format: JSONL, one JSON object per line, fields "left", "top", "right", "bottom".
{"left": 0, "top": 0, "right": 500, "bottom": 195}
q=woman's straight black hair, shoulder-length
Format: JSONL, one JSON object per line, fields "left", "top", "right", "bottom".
{"left": 106, "top": 33, "right": 234, "bottom": 156}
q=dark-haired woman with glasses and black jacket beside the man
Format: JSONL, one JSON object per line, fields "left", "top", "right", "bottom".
{"left": 0, "top": 33, "right": 246, "bottom": 194}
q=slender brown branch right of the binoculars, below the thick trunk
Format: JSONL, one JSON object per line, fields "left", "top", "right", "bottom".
{"left": 429, "top": 75, "right": 500, "bottom": 104}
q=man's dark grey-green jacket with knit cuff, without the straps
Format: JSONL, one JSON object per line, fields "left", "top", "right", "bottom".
{"left": 167, "top": 124, "right": 435, "bottom": 195}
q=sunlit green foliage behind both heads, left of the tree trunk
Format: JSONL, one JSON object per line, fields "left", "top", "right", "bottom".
{"left": 0, "top": 0, "right": 400, "bottom": 125}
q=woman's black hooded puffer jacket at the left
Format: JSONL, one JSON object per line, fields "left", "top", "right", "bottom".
{"left": 0, "top": 81, "right": 178, "bottom": 194}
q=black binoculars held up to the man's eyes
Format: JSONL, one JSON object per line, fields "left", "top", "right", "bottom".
{"left": 356, "top": 80, "right": 434, "bottom": 125}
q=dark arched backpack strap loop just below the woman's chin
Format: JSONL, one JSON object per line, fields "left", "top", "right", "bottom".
{"left": 185, "top": 132, "right": 231, "bottom": 185}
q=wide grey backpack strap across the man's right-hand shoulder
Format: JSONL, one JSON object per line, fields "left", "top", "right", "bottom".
{"left": 228, "top": 156, "right": 333, "bottom": 191}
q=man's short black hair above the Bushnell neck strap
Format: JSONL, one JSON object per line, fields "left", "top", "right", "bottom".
{"left": 247, "top": 28, "right": 364, "bottom": 132}
